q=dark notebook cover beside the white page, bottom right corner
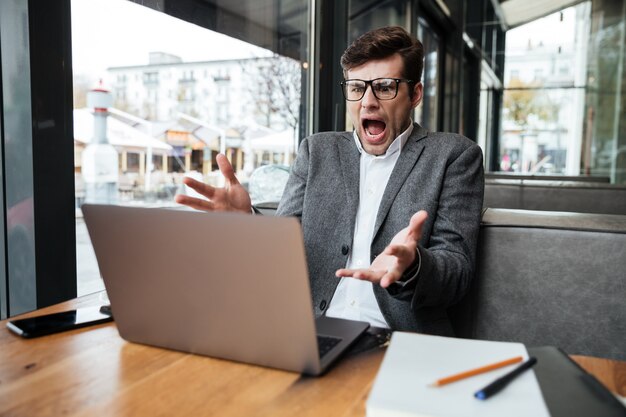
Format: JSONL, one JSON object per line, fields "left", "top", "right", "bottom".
{"left": 528, "top": 346, "right": 626, "bottom": 417}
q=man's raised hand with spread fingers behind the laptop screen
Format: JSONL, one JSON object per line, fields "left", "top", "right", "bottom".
{"left": 174, "top": 154, "right": 252, "bottom": 214}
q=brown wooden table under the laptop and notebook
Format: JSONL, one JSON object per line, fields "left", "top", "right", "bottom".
{"left": 0, "top": 294, "right": 626, "bottom": 417}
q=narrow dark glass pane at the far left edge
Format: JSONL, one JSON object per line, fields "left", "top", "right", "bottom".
{"left": 0, "top": 1, "right": 37, "bottom": 318}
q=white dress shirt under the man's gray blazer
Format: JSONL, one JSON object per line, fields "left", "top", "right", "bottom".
{"left": 326, "top": 123, "right": 413, "bottom": 328}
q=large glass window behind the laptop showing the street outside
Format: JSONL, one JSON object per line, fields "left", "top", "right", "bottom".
{"left": 71, "top": 0, "right": 309, "bottom": 295}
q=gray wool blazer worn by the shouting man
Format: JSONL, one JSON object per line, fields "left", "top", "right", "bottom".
{"left": 277, "top": 124, "right": 484, "bottom": 335}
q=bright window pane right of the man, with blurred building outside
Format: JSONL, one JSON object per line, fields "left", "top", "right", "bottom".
{"left": 499, "top": 2, "right": 590, "bottom": 175}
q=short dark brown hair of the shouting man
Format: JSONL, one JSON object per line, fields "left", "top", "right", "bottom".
{"left": 341, "top": 26, "right": 424, "bottom": 83}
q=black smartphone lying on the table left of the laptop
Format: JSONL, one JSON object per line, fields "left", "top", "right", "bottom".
{"left": 7, "top": 306, "right": 113, "bottom": 338}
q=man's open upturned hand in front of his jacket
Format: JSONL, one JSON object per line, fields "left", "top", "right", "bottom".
{"left": 335, "top": 210, "right": 428, "bottom": 288}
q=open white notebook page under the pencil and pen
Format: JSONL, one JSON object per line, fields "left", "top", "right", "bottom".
{"left": 366, "top": 332, "right": 550, "bottom": 417}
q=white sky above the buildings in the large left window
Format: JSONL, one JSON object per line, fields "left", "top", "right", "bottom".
{"left": 71, "top": 0, "right": 268, "bottom": 79}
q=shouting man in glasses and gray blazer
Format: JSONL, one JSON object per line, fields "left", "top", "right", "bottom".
{"left": 176, "top": 27, "right": 483, "bottom": 335}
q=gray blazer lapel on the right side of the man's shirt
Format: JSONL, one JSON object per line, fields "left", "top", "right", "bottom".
{"left": 372, "top": 123, "right": 427, "bottom": 236}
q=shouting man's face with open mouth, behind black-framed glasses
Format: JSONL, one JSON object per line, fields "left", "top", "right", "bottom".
{"left": 346, "top": 54, "right": 422, "bottom": 155}
